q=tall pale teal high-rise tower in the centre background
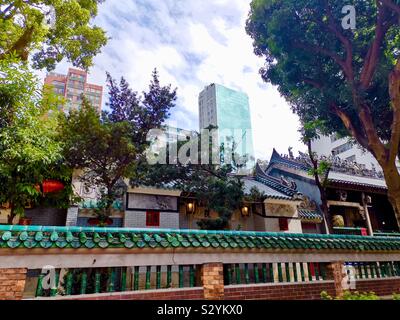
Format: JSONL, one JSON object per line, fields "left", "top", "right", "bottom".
{"left": 199, "top": 83, "right": 255, "bottom": 169}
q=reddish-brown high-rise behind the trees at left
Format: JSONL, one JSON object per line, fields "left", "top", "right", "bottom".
{"left": 44, "top": 68, "right": 103, "bottom": 112}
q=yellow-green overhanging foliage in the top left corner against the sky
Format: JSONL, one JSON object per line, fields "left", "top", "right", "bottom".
{"left": 0, "top": 0, "right": 107, "bottom": 71}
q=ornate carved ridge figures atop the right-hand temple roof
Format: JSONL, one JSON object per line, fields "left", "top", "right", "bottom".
{"left": 268, "top": 148, "right": 384, "bottom": 180}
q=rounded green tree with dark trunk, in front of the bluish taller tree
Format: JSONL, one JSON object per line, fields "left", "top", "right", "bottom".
{"left": 60, "top": 100, "right": 137, "bottom": 222}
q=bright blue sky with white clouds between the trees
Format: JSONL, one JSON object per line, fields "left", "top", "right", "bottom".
{"left": 47, "top": 0, "right": 305, "bottom": 160}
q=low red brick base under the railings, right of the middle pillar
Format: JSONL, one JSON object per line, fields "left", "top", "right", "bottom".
{"left": 224, "top": 281, "right": 335, "bottom": 300}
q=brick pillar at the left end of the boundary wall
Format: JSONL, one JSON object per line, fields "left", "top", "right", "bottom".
{"left": 0, "top": 268, "right": 27, "bottom": 300}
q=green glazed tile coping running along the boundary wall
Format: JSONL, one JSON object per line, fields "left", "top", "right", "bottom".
{"left": 0, "top": 226, "right": 400, "bottom": 252}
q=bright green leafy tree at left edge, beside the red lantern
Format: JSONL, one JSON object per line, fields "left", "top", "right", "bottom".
{"left": 0, "top": 60, "right": 68, "bottom": 224}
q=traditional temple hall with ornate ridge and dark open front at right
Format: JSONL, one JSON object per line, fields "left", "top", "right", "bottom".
{"left": 263, "top": 150, "right": 399, "bottom": 235}
